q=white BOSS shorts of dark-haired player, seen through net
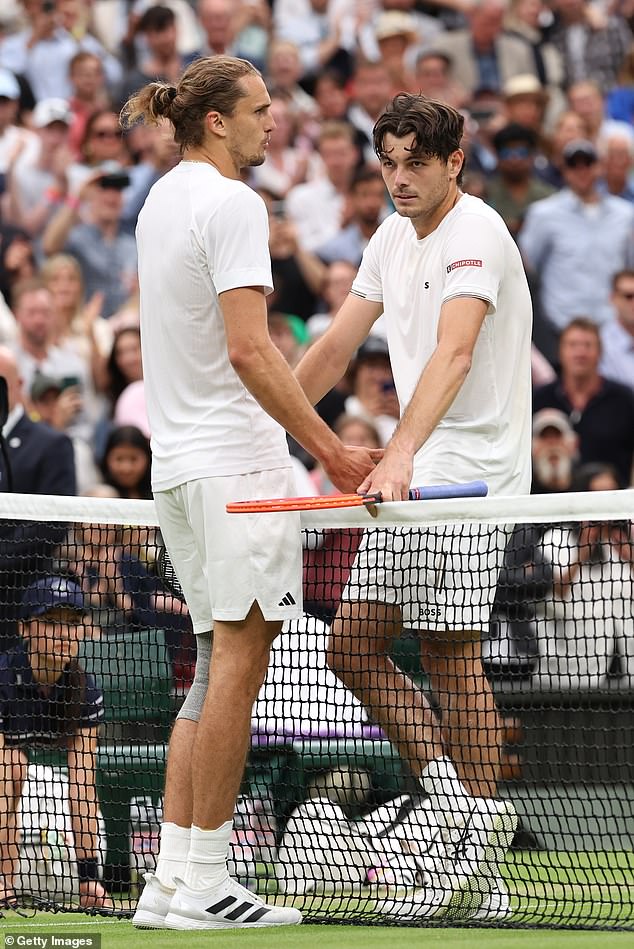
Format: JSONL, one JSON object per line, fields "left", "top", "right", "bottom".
{"left": 341, "top": 524, "right": 508, "bottom": 631}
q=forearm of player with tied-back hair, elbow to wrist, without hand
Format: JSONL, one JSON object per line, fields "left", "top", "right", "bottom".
{"left": 231, "top": 343, "right": 340, "bottom": 463}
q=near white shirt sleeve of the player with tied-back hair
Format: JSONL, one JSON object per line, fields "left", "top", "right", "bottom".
{"left": 203, "top": 187, "right": 273, "bottom": 293}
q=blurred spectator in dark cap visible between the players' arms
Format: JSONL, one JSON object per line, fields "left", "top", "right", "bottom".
{"left": 345, "top": 336, "right": 399, "bottom": 446}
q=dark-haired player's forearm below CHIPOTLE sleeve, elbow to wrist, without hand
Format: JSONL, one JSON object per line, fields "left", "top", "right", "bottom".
{"left": 388, "top": 350, "right": 471, "bottom": 458}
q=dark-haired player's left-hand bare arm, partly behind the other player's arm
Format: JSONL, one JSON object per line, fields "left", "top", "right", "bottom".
{"left": 295, "top": 293, "right": 383, "bottom": 405}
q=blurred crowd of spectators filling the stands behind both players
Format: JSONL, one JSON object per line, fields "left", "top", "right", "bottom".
{"left": 0, "top": 0, "right": 634, "bottom": 684}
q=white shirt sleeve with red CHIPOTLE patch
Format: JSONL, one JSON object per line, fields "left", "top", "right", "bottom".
{"left": 441, "top": 214, "right": 506, "bottom": 312}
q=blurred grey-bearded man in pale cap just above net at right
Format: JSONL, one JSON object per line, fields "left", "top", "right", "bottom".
{"left": 531, "top": 409, "right": 579, "bottom": 494}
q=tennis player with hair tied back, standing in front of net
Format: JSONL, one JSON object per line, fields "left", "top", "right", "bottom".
{"left": 122, "top": 56, "right": 380, "bottom": 929}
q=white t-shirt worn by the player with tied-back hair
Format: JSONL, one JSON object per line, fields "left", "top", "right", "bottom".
{"left": 136, "top": 162, "right": 288, "bottom": 491}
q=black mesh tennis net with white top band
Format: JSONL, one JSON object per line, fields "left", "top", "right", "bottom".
{"left": 0, "top": 491, "right": 634, "bottom": 929}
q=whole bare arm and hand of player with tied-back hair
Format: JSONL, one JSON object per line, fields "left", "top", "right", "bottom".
{"left": 220, "top": 287, "right": 381, "bottom": 491}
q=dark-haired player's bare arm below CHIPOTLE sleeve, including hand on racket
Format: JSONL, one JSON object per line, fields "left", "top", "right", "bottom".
{"left": 359, "top": 297, "right": 488, "bottom": 501}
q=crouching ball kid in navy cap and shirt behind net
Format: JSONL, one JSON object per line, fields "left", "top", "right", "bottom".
{"left": 0, "top": 575, "right": 112, "bottom": 909}
